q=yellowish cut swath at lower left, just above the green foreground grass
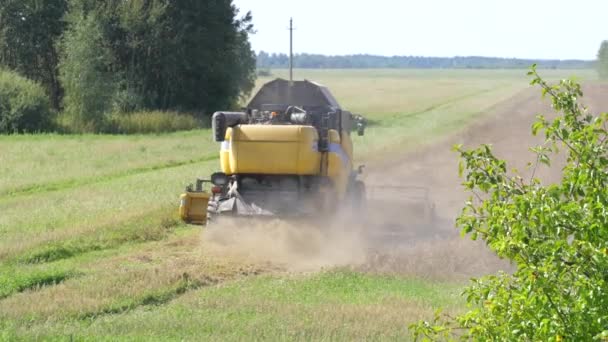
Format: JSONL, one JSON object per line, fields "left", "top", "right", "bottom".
{"left": 0, "top": 227, "right": 270, "bottom": 324}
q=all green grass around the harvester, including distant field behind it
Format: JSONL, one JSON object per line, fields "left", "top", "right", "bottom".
{"left": 0, "top": 70, "right": 595, "bottom": 340}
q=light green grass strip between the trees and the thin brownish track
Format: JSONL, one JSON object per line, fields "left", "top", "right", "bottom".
{"left": 0, "top": 130, "right": 219, "bottom": 198}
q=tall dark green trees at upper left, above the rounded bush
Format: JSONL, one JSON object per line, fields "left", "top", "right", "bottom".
{"left": 0, "top": 0, "right": 255, "bottom": 131}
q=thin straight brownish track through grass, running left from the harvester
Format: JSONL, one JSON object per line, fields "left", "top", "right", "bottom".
{"left": 0, "top": 153, "right": 219, "bottom": 200}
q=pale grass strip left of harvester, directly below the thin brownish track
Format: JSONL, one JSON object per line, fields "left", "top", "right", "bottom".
{"left": 0, "top": 161, "right": 216, "bottom": 260}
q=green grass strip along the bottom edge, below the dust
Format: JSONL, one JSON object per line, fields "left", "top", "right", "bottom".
{"left": 5, "top": 270, "right": 462, "bottom": 341}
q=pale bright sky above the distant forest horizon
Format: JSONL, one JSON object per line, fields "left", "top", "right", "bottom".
{"left": 234, "top": 0, "right": 608, "bottom": 59}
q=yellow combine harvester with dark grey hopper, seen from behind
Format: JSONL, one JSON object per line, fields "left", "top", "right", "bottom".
{"left": 179, "top": 79, "right": 365, "bottom": 224}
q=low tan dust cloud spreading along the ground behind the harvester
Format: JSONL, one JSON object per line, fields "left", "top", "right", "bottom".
{"left": 203, "top": 207, "right": 510, "bottom": 280}
